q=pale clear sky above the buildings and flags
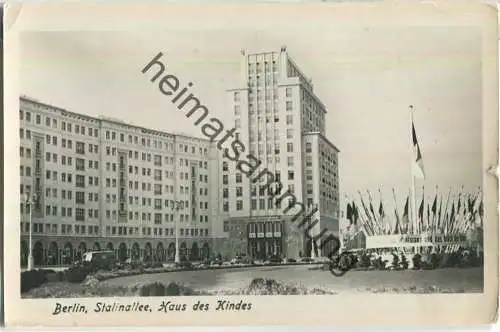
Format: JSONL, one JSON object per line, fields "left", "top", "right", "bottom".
{"left": 20, "top": 26, "right": 482, "bottom": 220}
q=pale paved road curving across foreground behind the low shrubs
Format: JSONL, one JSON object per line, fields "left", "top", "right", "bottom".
{"left": 104, "top": 266, "right": 483, "bottom": 292}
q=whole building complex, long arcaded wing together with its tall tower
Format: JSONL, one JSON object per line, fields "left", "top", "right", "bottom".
{"left": 19, "top": 49, "right": 339, "bottom": 265}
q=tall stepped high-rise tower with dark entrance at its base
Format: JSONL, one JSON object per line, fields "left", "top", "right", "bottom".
{"left": 214, "top": 48, "right": 339, "bottom": 259}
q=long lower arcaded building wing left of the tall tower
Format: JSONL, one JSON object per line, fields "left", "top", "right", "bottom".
{"left": 19, "top": 97, "right": 217, "bottom": 266}
